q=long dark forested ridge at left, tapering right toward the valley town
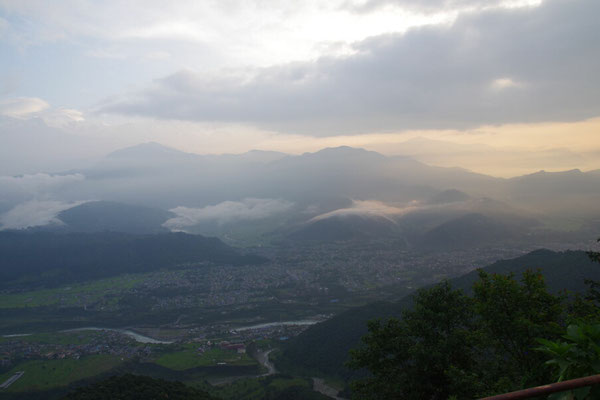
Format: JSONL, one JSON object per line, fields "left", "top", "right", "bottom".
{"left": 0, "top": 232, "right": 266, "bottom": 288}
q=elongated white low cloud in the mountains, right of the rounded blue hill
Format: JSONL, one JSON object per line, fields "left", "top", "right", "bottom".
{"left": 163, "top": 198, "right": 293, "bottom": 230}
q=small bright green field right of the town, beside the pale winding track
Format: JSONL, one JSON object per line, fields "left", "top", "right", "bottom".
{"left": 155, "top": 343, "right": 256, "bottom": 371}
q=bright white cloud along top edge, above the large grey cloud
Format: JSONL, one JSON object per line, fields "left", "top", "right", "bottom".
{"left": 0, "top": 0, "right": 436, "bottom": 68}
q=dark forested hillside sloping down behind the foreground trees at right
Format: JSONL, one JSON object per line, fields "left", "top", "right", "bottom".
{"left": 278, "top": 250, "right": 600, "bottom": 379}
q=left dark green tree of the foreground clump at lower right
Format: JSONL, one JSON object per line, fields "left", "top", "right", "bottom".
{"left": 349, "top": 282, "right": 474, "bottom": 400}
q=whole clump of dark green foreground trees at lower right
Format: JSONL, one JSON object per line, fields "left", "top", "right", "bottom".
{"left": 349, "top": 271, "right": 566, "bottom": 400}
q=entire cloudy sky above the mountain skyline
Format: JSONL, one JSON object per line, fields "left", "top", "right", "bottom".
{"left": 0, "top": 0, "right": 600, "bottom": 176}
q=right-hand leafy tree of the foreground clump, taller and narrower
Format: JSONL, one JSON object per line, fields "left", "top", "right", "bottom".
{"left": 473, "top": 271, "right": 565, "bottom": 388}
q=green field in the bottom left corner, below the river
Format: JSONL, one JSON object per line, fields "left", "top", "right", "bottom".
{"left": 0, "top": 355, "right": 122, "bottom": 392}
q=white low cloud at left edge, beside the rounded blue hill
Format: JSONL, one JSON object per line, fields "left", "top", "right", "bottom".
{"left": 0, "top": 200, "right": 84, "bottom": 230}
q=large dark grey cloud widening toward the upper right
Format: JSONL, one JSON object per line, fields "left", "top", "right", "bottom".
{"left": 100, "top": 0, "right": 600, "bottom": 136}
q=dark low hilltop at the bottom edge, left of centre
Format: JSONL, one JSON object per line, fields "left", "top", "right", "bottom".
{"left": 62, "top": 374, "right": 215, "bottom": 400}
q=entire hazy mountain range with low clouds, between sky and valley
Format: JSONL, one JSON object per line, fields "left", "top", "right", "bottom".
{"left": 0, "top": 143, "right": 600, "bottom": 246}
